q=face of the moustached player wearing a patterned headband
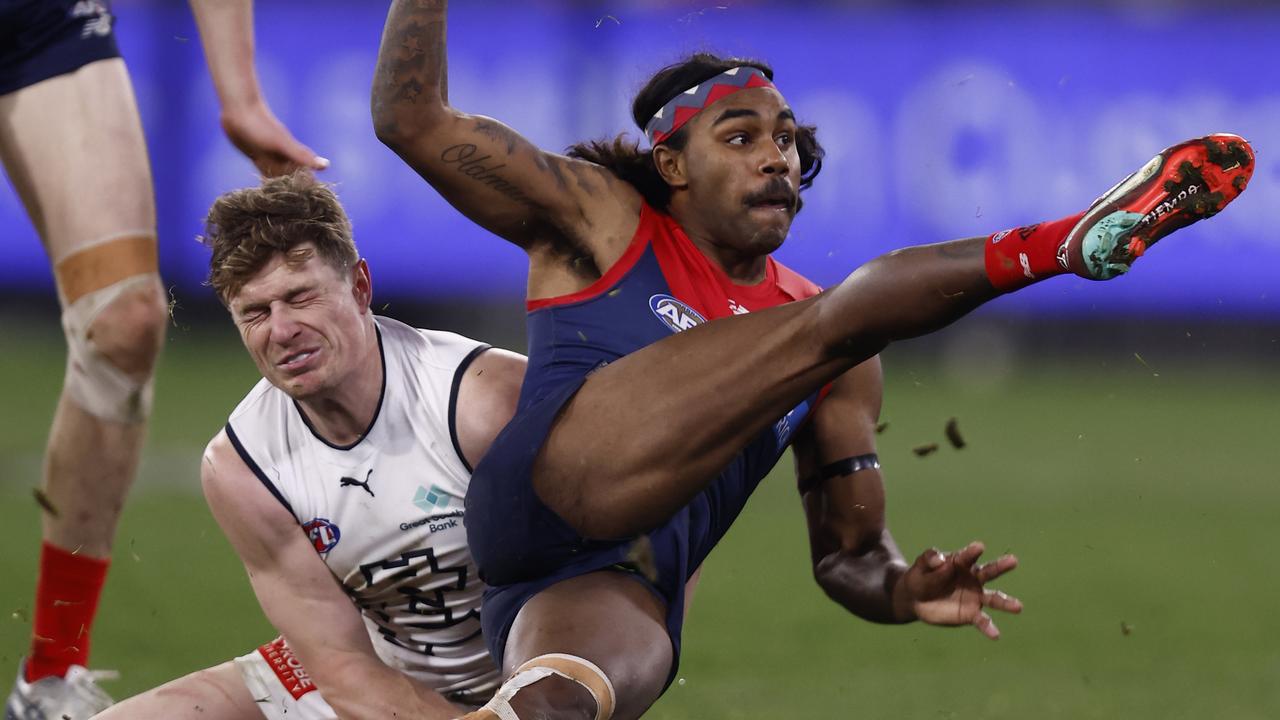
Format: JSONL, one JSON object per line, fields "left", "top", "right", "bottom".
{"left": 684, "top": 87, "right": 800, "bottom": 255}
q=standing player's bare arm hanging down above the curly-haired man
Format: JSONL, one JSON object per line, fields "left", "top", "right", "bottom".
{"left": 189, "top": 0, "right": 329, "bottom": 176}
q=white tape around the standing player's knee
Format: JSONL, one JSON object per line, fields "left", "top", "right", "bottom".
{"left": 63, "top": 273, "right": 159, "bottom": 423}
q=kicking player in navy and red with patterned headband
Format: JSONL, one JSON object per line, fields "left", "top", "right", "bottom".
{"left": 372, "top": 0, "right": 1253, "bottom": 720}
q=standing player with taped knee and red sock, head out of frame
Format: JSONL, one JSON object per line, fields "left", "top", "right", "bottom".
{"left": 0, "top": 0, "right": 323, "bottom": 720}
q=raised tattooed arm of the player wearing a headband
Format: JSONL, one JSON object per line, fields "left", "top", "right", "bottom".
{"left": 372, "top": 0, "right": 640, "bottom": 260}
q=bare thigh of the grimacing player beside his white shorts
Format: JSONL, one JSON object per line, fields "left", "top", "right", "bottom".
{"left": 93, "top": 662, "right": 262, "bottom": 720}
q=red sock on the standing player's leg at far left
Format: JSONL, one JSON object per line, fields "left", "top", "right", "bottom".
{"left": 27, "top": 542, "right": 111, "bottom": 683}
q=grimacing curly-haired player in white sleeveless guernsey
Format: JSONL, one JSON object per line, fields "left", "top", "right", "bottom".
{"left": 92, "top": 173, "right": 525, "bottom": 720}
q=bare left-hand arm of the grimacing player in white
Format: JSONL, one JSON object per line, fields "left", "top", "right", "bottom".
{"left": 200, "top": 433, "right": 458, "bottom": 720}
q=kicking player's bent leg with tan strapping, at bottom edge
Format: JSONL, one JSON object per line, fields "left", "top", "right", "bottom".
{"left": 467, "top": 570, "right": 673, "bottom": 720}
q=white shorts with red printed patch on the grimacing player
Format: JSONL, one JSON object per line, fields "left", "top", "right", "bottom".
{"left": 236, "top": 638, "right": 338, "bottom": 720}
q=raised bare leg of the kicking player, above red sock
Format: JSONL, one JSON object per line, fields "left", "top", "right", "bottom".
{"left": 534, "top": 238, "right": 998, "bottom": 538}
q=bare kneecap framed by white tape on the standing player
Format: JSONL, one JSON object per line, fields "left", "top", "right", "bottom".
{"left": 88, "top": 278, "right": 169, "bottom": 379}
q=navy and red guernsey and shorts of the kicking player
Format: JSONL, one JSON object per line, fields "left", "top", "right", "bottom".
{"left": 466, "top": 205, "right": 820, "bottom": 682}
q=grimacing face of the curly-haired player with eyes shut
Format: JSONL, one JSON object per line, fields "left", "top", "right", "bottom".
{"left": 228, "top": 246, "right": 371, "bottom": 400}
